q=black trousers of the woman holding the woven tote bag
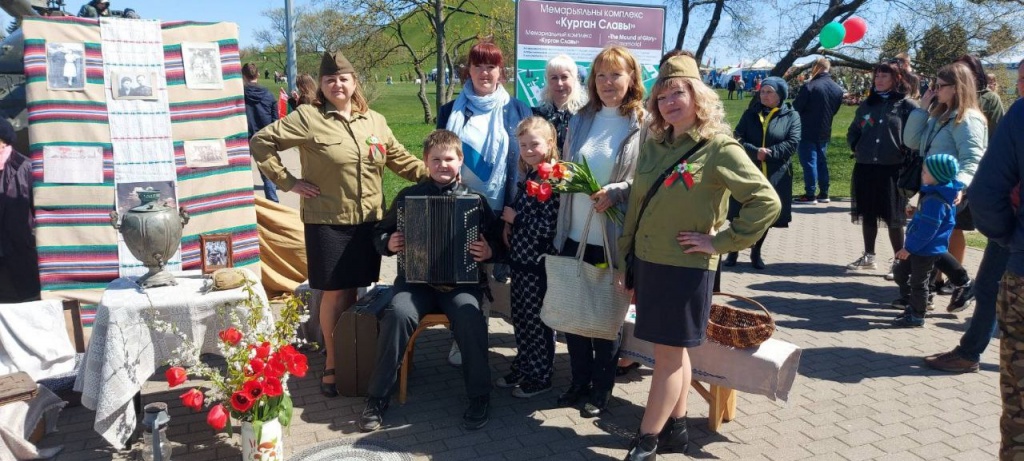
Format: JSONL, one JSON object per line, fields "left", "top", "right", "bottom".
{"left": 560, "top": 239, "right": 623, "bottom": 392}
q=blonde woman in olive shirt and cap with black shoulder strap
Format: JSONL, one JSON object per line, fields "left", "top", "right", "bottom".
{"left": 618, "top": 56, "right": 782, "bottom": 461}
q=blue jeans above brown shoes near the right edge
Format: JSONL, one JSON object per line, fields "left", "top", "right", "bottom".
{"left": 955, "top": 241, "right": 1010, "bottom": 362}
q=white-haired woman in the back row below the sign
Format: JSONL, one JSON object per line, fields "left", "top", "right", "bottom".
{"left": 534, "top": 54, "right": 587, "bottom": 149}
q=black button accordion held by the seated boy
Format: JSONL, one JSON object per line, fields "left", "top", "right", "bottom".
{"left": 398, "top": 196, "right": 483, "bottom": 285}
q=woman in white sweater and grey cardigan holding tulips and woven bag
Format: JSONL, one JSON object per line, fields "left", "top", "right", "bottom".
{"left": 555, "top": 45, "right": 645, "bottom": 418}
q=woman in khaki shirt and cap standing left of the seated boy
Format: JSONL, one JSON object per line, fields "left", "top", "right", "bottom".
{"left": 249, "top": 51, "right": 427, "bottom": 396}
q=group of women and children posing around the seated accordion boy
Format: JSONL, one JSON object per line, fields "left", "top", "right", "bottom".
{"left": 245, "top": 42, "right": 774, "bottom": 460}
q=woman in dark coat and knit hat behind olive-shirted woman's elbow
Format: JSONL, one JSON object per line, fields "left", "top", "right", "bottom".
{"left": 722, "top": 77, "right": 800, "bottom": 269}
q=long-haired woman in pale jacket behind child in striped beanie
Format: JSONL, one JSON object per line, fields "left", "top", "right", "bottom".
{"left": 903, "top": 62, "right": 988, "bottom": 311}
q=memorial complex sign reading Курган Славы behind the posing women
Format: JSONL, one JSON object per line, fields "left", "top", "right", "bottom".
{"left": 515, "top": 0, "right": 665, "bottom": 107}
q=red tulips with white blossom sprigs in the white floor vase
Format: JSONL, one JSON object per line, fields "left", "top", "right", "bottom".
{"left": 153, "top": 282, "right": 309, "bottom": 434}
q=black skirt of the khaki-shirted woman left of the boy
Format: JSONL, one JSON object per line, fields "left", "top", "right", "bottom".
{"left": 305, "top": 222, "right": 381, "bottom": 291}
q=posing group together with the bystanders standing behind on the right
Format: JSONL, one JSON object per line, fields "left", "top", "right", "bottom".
{"left": 243, "top": 42, "right": 1024, "bottom": 460}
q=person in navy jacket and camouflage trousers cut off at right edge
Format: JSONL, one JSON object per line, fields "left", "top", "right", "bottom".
{"left": 967, "top": 99, "right": 1024, "bottom": 459}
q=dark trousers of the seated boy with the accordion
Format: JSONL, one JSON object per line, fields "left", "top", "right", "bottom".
{"left": 369, "top": 278, "right": 492, "bottom": 399}
